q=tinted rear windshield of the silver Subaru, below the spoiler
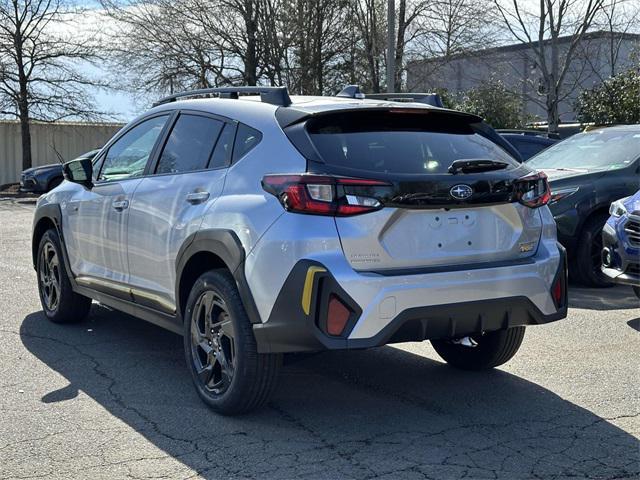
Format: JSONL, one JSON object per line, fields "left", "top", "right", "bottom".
{"left": 307, "top": 111, "right": 518, "bottom": 174}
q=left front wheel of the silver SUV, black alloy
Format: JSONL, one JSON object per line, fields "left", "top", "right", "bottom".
{"left": 37, "top": 229, "right": 91, "bottom": 323}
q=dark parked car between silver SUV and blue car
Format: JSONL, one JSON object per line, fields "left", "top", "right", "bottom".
{"left": 527, "top": 125, "right": 640, "bottom": 286}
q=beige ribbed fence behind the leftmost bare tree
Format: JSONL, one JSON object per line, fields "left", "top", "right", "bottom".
{"left": 0, "top": 121, "right": 122, "bottom": 185}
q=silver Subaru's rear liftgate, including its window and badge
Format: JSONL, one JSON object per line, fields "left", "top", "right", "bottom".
{"left": 306, "top": 109, "right": 542, "bottom": 271}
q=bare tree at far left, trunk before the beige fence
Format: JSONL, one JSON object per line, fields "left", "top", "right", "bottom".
{"left": 0, "top": 0, "right": 104, "bottom": 169}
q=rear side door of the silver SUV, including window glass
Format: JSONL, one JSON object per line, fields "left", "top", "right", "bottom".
{"left": 127, "top": 111, "right": 236, "bottom": 313}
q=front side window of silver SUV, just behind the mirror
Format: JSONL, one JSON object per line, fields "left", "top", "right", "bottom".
{"left": 98, "top": 115, "right": 168, "bottom": 180}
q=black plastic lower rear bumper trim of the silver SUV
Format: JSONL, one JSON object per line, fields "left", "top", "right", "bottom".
{"left": 253, "top": 253, "right": 567, "bottom": 353}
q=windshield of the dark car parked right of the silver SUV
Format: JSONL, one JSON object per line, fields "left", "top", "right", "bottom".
{"left": 527, "top": 129, "right": 640, "bottom": 170}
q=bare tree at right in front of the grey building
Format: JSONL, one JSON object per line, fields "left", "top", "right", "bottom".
{"left": 494, "top": 0, "right": 603, "bottom": 132}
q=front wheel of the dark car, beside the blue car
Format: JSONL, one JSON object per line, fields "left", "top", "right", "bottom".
{"left": 574, "top": 214, "right": 613, "bottom": 287}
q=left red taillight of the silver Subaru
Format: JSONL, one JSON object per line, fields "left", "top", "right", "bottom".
{"left": 262, "top": 174, "right": 391, "bottom": 217}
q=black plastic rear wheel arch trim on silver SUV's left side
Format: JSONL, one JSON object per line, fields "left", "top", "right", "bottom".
{"left": 175, "top": 228, "right": 262, "bottom": 324}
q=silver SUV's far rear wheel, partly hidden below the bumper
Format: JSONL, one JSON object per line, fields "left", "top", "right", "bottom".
{"left": 431, "top": 327, "right": 525, "bottom": 370}
